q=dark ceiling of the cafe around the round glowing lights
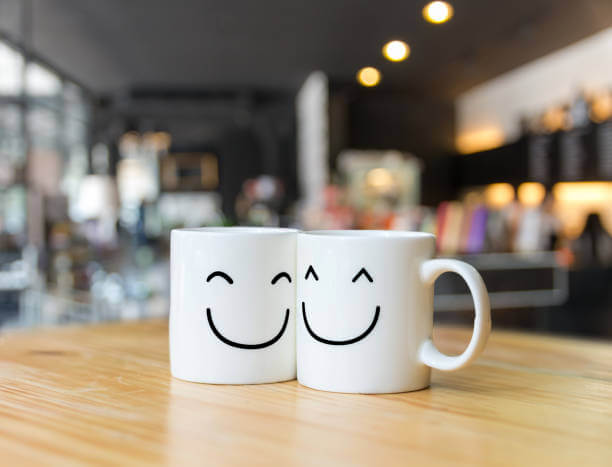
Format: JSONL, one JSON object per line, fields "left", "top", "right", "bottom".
{"left": 0, "top": 0, "right": 612, "bottom": 98}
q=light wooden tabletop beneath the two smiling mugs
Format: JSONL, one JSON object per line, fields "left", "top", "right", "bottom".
{"left": 0, "top": 321, "right": 612, "bottom": 467}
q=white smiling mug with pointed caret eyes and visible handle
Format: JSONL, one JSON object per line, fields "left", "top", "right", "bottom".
{"left": 296, "top": 230, "right": 491, "bottom": 393}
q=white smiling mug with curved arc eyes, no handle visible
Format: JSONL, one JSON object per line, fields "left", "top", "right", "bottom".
{"left": 170, "top": 227, "right": 297, "bottom": 384}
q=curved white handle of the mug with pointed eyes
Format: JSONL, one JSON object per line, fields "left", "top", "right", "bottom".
{"left": 419, "top": 258, "right": 491, "bottom": 371}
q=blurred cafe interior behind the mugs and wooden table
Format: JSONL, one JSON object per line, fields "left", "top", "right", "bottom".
{"left": 0, "top": 0, "right": 612, "bottom": 338}
